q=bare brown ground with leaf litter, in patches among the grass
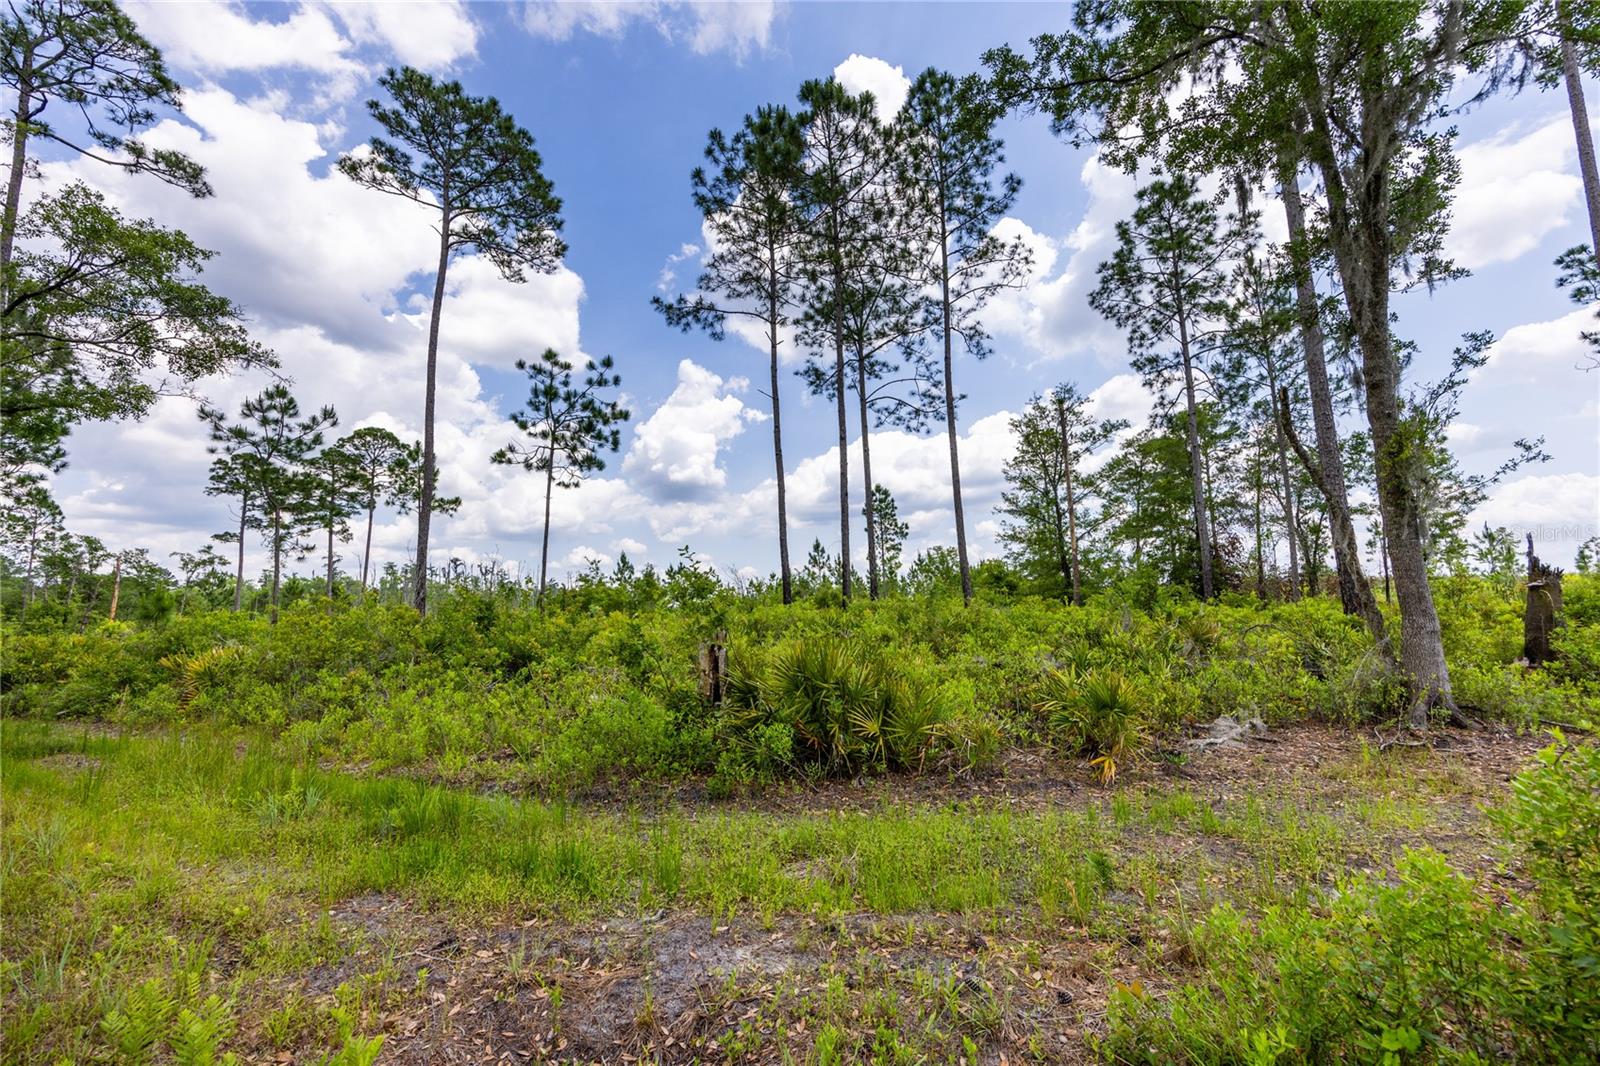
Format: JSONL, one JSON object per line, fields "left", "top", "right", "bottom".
{"left": 248, "top": 723, "right": 1544, "bottom": 1063}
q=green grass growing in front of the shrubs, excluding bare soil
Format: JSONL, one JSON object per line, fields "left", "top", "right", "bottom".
{"left": 0, "top": 720, "right": 1523, "bottom": 1063}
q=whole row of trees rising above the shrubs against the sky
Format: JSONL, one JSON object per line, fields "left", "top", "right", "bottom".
{"left": 0, "top": 0, "right": 1600, "bottom": 723}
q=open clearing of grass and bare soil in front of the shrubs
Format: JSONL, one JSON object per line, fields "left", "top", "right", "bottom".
{"left": 3, "top": 722, "right": 1547, "bottom": 1063}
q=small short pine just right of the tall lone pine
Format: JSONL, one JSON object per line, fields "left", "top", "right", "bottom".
{"left": 491, "top": 349, "right": 629, "bottom": 600}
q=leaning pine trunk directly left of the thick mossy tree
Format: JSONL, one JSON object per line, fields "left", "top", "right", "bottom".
{"left": 1278, "top": 158, "right": 1389, "bottom": 633}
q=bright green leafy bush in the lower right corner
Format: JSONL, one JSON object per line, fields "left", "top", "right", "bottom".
{"left": 1101, "top": 736, "right": 1600, "bottom": 1063}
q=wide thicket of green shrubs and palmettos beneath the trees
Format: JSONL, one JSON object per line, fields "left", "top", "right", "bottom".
{"left": 0, "top": 573, "right": 1600, "bottom": 794}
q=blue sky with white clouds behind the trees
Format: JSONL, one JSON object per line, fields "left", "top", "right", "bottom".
{"left": 35, "top": 0, "right": 1600, "bottom": 578}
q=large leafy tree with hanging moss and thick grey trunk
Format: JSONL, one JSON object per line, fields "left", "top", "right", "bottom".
{"left": 986, "top": 0, "right": 1561, "bottom": 713}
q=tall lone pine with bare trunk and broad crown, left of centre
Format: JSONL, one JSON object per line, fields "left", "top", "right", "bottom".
{"left": 339, "top": 67, "right": 566, "bottom": 615}
